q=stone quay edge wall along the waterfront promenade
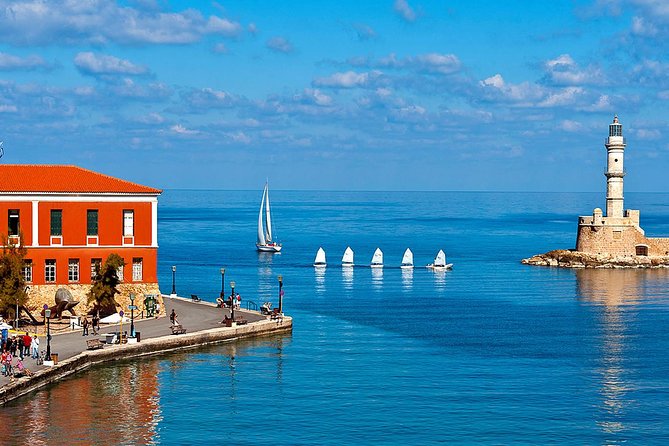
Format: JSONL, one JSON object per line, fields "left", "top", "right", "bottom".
{"left": 0, "top": 316, "right": 293, "bottom": 405}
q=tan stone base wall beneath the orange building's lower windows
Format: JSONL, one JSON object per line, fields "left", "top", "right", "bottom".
{"left": 27, "top": 283, "right": 165, "bottom": 319}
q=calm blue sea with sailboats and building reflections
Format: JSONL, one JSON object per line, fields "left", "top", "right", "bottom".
{"left": 0, "top": 190, "right": 669, "bottom": 446}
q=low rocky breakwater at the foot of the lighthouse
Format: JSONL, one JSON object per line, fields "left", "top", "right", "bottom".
{"left": 520, "top": 249, "right": 669, "bottom": 268}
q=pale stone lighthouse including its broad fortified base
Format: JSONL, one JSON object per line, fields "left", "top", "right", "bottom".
{"left": 576, "top": 116, "right": 669, "bottom": 257}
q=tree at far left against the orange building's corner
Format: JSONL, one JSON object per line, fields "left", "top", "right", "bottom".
{"left": 0, "top": 234, "right": 28, "bottom": 319}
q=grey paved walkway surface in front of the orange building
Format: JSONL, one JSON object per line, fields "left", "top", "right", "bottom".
{"left": 0, "top": 296, "right": 266, "bottom": 385}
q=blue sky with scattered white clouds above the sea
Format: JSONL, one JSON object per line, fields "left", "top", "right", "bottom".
{"left": 0, "top": 0, "right": 669, "bottom": 192}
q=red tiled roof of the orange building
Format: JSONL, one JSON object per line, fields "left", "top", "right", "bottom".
{"left": 0, "top": 164, "right": 162, "bottom": 194}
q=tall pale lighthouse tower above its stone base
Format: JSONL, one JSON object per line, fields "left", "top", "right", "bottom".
{"left": 604, "top": 116, "right": 625, "bottom": 218}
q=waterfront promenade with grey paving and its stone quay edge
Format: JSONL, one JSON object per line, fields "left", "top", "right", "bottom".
{"left": 0, "top": 296, "right": 292, "bottom": 404}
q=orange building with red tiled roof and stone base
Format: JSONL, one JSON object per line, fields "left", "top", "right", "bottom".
{"left": 0, "top": 164, "right": 161, "bottom": 310}
